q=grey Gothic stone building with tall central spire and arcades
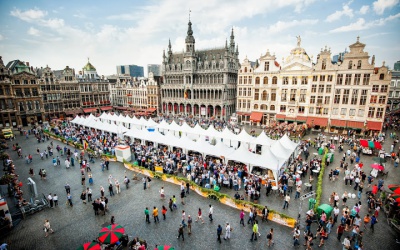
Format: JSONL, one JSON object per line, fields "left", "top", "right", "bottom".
{"left": 160, "top": 20, "right": 240, "bottom": 119}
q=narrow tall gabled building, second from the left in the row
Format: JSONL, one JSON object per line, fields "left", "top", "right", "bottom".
{"left": 37, "top": 66, "right": 64, "bottom": 121}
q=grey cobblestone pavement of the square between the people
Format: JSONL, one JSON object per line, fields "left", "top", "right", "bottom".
{"left": 1, "top": 131, "right": 399, "bottom": 250}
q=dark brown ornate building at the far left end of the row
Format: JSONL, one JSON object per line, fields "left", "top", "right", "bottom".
{"left": 6, "top": 60, "right": 44, "bottom": 126}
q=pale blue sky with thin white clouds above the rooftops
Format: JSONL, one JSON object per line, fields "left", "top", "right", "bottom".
{"left": 0, "top": 0, "right": 400, "bottom": 75}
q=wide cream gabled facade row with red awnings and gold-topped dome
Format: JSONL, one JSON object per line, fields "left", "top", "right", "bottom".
{"left": 237, "top": 37, "right": 391, "bottom": 131}
